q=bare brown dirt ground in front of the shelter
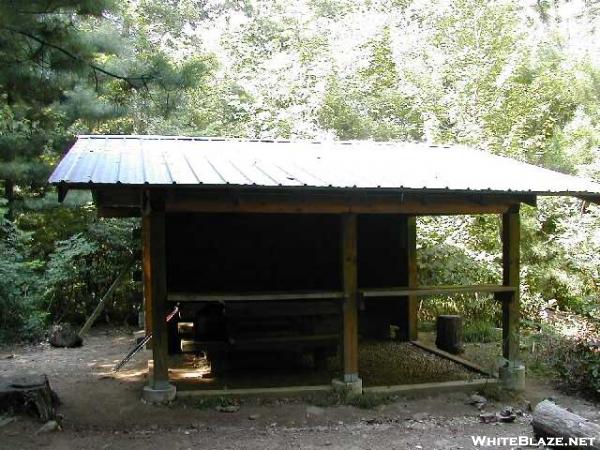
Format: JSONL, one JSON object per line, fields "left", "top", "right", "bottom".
{"left": 0, "top": 329, "right": 600, "bottom": 450}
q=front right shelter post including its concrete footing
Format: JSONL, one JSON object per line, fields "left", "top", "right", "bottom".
{"left": 499, "top": 205, "right": 525, "bottom": 390}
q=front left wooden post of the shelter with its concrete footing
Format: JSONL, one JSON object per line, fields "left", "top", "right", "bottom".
{"left": 143, "top": 196, "right": 175, "bottom": 402}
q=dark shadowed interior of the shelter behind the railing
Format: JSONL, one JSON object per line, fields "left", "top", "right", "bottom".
{"left": 165, "top": 213, "right": 408, "bottom": 373}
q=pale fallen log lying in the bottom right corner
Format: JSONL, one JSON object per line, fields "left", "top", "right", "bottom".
{"left": 531, "top": 400, "right": 600, "bottom": 450}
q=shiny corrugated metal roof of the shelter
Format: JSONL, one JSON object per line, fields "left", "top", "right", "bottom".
{"left": 50, "top": 136, "right": 600, "bottom": 195}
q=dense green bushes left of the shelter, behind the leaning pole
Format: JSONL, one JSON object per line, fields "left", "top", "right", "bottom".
{"left": 0, "top": 200, "right": 140, "bottom": 341}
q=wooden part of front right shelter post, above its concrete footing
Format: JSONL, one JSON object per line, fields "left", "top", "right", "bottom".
{"left": 498, "top": 208, "right": 521, "bottom": 361}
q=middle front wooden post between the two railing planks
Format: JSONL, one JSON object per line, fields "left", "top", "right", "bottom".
{"left": 341, "top": 214, "right": 359, "bottom": 383}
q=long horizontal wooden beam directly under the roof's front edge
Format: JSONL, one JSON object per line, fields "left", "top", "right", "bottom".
{"left": 95, "top": 187, "right": 535, "bottom": 217}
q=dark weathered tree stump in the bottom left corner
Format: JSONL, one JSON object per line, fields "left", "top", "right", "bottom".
{"left": 0, "top": 374, "right": 59, "bottom": 422}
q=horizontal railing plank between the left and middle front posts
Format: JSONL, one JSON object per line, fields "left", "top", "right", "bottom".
{"left": 167, "top": 291, "right": 344, "bottom": 302}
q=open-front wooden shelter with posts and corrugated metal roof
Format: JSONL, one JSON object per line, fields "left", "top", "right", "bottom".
{"left": 50, "top": 136, "right": 600, "bottom": 398}
